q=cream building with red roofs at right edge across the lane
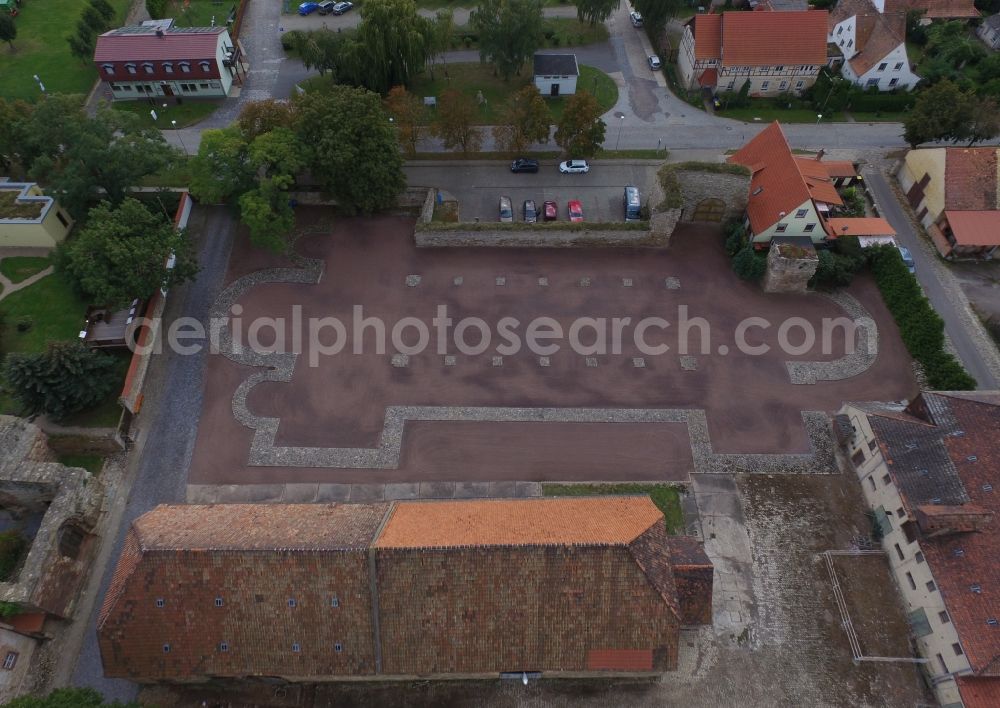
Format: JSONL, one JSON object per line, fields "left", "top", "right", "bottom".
{"left": 896, "top": 147, "right": 1000, "bottom": 258}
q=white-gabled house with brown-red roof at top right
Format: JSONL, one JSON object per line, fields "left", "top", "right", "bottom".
{"left": 827, "top": 0, "right": 920, "bottom": 91}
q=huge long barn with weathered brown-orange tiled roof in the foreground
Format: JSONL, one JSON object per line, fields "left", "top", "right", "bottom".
{"left": 97, "top": 497, "right": 713, "bottom": 682}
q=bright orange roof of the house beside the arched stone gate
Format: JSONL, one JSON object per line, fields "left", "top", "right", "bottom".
{"left": 728, "top": 121, "right": 843, "bottom": 233}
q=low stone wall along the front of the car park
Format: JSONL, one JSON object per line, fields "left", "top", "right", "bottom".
{"left": 413, "top": 228, "right": 664, "bottom": 248}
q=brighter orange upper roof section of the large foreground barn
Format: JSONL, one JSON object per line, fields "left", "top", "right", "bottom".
{"left": 374, "top": 496, "right": 663, "bottom": 548}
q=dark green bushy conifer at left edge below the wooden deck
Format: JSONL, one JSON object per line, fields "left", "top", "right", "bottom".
{"left": 2, "top": 341, "right": 120, "bottom": 420}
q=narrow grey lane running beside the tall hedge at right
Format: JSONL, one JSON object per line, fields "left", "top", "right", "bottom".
{"left": 864, "top": 169, "right": 998, "bottom": 389}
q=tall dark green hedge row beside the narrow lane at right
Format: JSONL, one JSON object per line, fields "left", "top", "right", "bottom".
{"left": 869, "top": 246, "right": 976, "bottom": 391}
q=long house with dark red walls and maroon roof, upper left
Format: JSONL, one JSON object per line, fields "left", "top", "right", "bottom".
{"left": 94, "top": 25, "right": 241, "bottom": 101}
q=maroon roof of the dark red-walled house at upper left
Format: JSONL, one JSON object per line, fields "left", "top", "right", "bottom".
{"left": 94, "top": 27, "right": 226, "bottom": 63}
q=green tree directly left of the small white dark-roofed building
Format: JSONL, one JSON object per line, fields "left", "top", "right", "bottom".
{"left": 469, "top": 0, "right": 543, "bottom": 81}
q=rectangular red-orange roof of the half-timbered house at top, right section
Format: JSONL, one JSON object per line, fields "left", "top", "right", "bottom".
{"left": 722, "top": 10, "right": 829, "bottom": 67}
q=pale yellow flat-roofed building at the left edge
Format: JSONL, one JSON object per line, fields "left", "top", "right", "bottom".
{"left": 0, "top": 179, "right": 73, "bottom": 248}
